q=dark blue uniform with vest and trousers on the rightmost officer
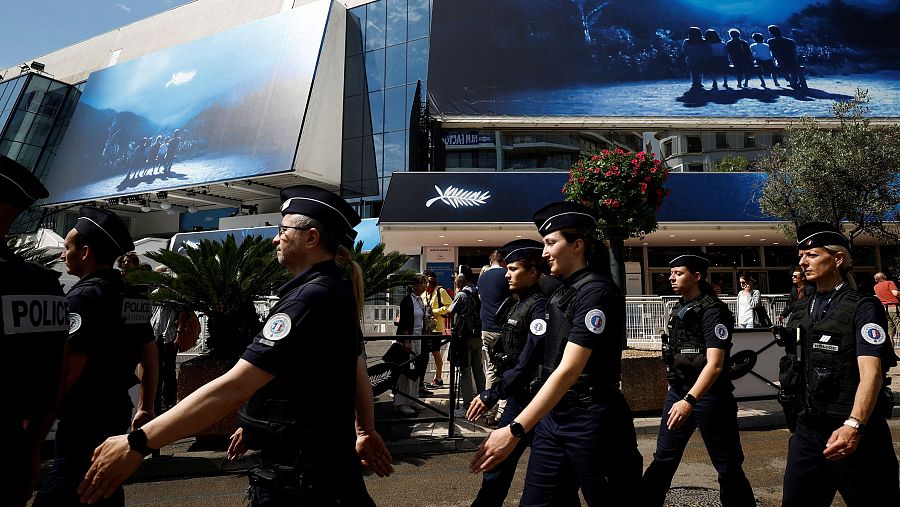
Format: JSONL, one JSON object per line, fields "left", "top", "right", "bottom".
{"left": 782, "top": 284, "right": 900, "bottom": 507}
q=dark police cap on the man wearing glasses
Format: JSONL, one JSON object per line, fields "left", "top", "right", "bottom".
{"left": 281, "top": 185, "right": 362, "bottom": 248}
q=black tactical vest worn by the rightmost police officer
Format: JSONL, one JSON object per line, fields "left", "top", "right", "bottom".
{"left": 790, "top": 290, "right": 865, "bottom": 418}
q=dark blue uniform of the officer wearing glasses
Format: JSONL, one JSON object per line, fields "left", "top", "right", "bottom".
{"left": 241, "top": 260, "right": 374, "bottom": 506}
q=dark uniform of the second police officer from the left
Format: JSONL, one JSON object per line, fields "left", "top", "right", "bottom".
{"left": 34, "top": 268, "right": 154, "bottom": 507}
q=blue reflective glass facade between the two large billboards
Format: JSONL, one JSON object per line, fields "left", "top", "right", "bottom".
{"left": 341, "top": 0, "right": 431, "bottom": 218}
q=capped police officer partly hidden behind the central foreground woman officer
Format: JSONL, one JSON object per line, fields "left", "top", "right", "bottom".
{"left": 466, "top": 239, "right": 580, "bottom": 507}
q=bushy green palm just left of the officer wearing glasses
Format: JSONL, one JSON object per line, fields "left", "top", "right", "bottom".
{"left": 128, "top": 234, "right": 290, "bottom": 363}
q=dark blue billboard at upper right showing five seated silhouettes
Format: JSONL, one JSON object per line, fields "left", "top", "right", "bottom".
{"left": 428, "top": 0, "right": 900, "bottom": 118}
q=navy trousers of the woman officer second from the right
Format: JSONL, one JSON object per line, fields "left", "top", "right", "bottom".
{"left": 641, "top": 389, "right": 756, "bottom": 507}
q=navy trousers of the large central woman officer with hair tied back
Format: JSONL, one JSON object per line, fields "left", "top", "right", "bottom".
{"left": 519, "top": 390, "right": 642, "bottom": 506}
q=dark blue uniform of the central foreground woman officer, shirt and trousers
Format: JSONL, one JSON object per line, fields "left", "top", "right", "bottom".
{"left": 521, "top": 269, "right": 641, "bottom": 506}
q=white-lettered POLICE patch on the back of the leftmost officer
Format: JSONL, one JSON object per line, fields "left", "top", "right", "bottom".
{"left": 0, "top": 295, "right": 69, "bottom": 335}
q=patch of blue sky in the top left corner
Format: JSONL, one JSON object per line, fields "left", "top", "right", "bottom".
{"left": 0, "top": 0, "right": 191, "bottom": 70}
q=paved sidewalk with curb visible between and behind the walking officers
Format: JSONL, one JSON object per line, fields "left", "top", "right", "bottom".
{"left": 121, "top": 366, "right": 900, "bottom": 482}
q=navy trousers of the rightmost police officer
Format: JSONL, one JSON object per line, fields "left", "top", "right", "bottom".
{"left": 781, "top": 415, "right": 900, "bottom": 507}
